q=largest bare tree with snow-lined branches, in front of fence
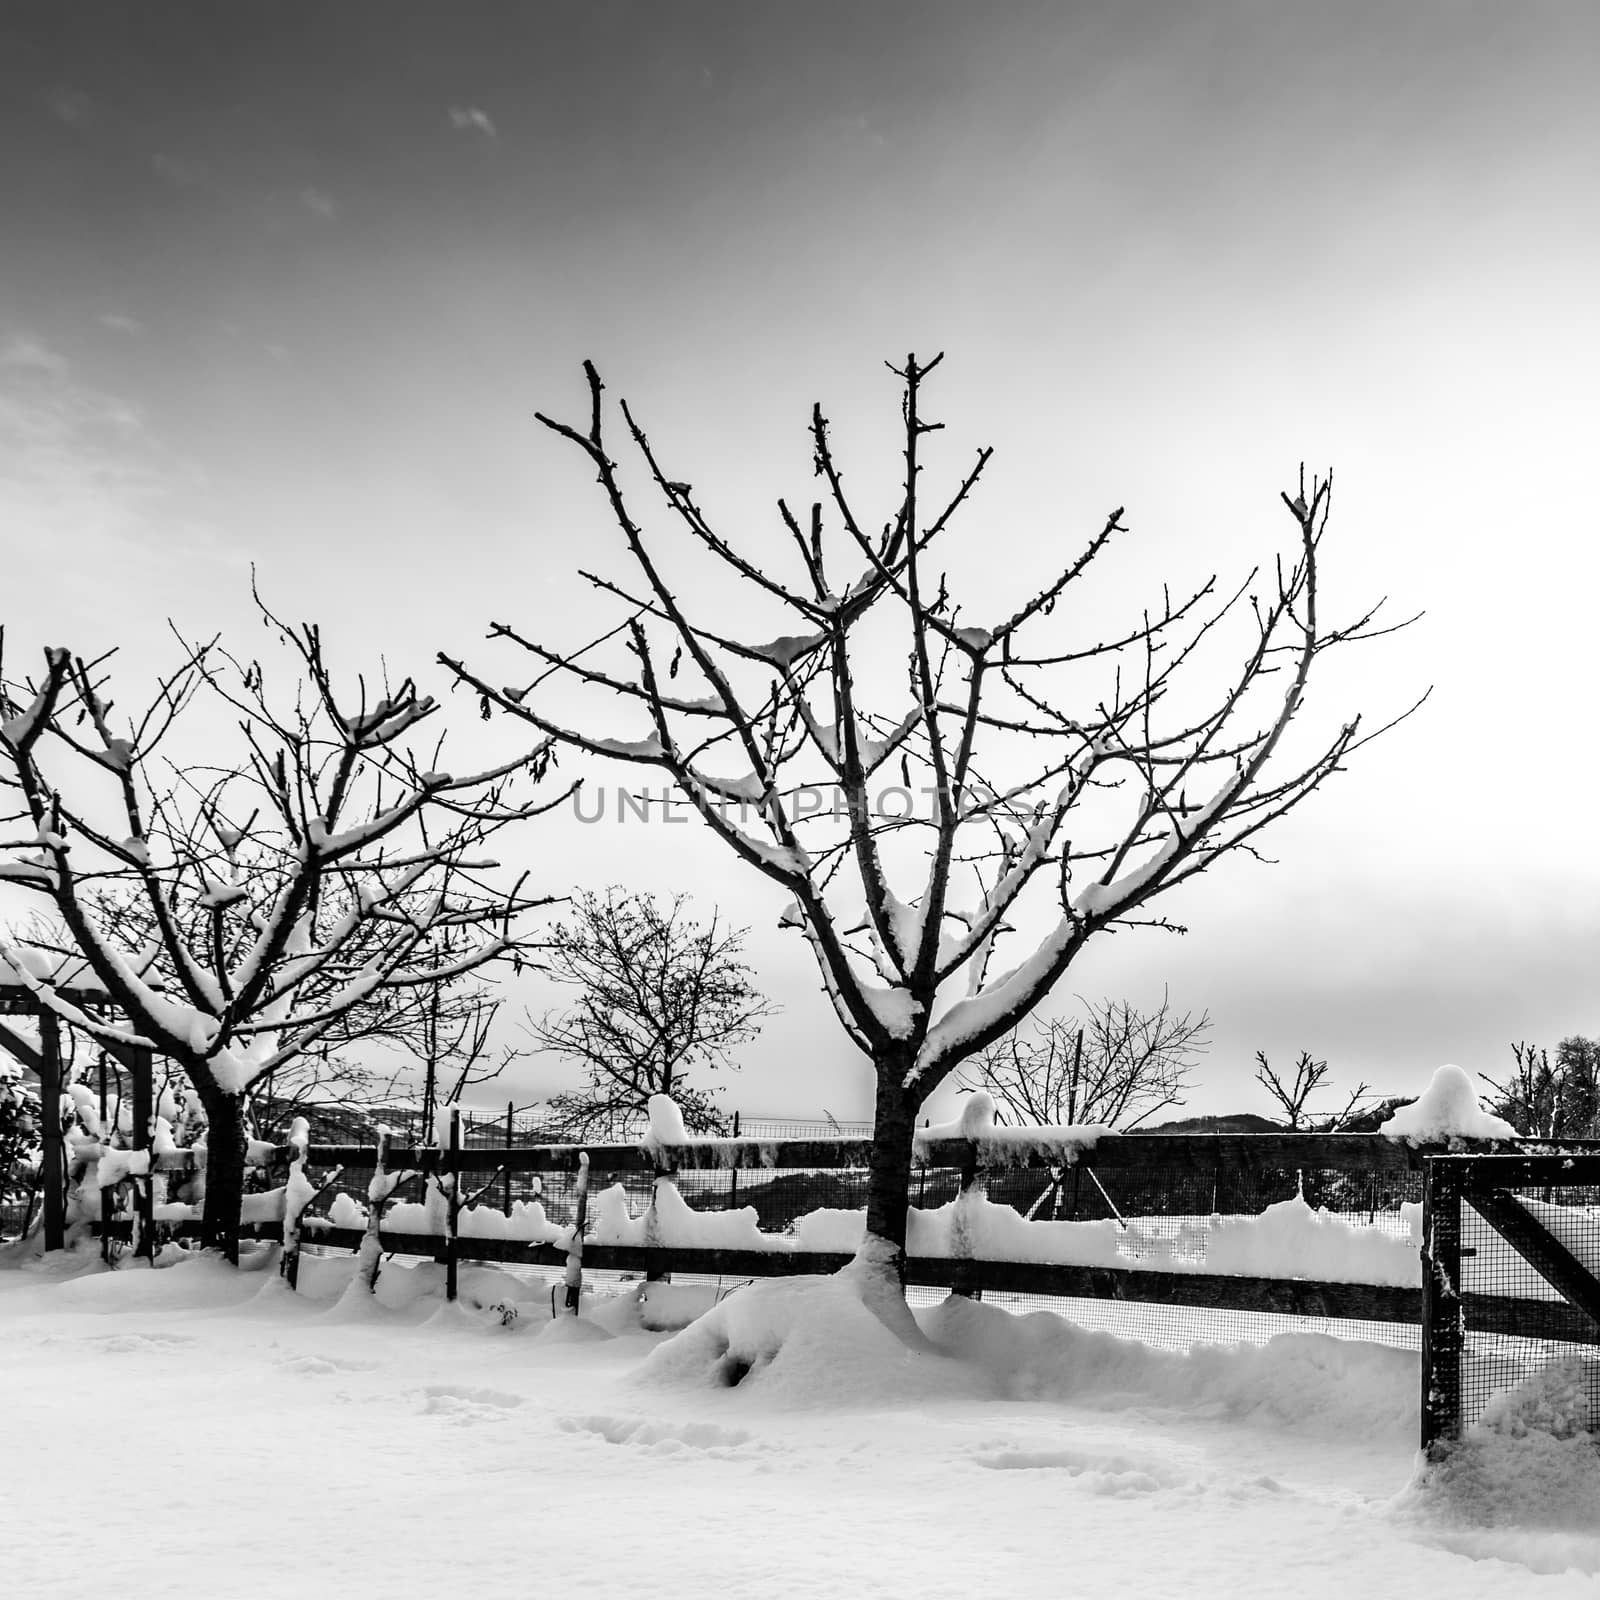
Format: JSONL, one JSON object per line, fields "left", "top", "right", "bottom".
{"left": 442, "top": 357, "right": 1420, "bottom": 1299}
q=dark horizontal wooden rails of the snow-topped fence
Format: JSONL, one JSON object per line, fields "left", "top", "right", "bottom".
{"left": 80, "top": 1133, "right": 1600, "bottom": 1339}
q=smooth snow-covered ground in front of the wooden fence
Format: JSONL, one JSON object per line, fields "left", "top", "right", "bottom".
{"left": 0, "top": 1251, "right": 1600, "bottom": 1600}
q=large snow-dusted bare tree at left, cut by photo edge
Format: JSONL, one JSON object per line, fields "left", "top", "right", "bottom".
{"left": 0, "top": 608, "right": 558, "bottom": 1259}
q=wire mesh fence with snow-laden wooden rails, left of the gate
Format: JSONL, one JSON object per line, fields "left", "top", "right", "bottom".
{"left": 278, "top": 1115, "right": 1452, "bottom": 1347}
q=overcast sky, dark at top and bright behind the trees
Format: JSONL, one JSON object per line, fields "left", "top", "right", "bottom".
{"left": 0, "top": 0, "right": 1600, "bottom": 1117}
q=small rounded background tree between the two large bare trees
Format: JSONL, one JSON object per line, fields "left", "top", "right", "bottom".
{"left": 533, "top": 886, "right": 773, "bottom": 1142}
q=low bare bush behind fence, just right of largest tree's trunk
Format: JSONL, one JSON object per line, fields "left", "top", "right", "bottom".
{"left": 957, "top": 994, "right": 1211, "bottom": 1131}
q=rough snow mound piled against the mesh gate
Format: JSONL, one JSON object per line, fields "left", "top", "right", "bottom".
{"left": 1395, "top": 1357, "right": 1600, "bottom": 1550}
